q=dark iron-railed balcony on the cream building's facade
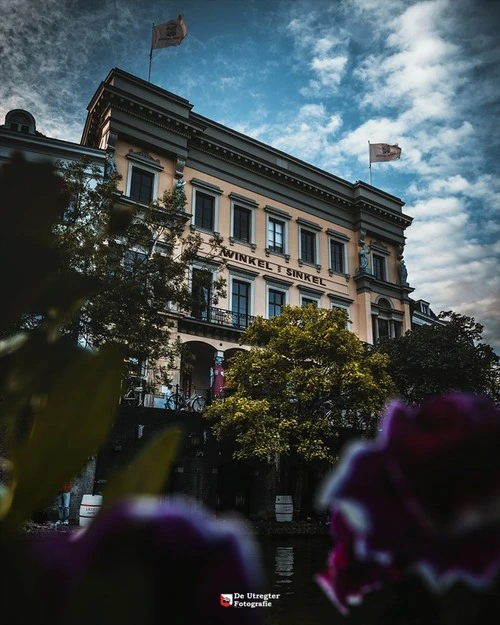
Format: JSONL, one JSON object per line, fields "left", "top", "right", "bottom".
{"left": 179, "top": 306, "right": 255, "bottom": 341}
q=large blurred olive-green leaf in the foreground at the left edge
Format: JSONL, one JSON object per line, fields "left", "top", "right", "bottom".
{"left": 5, "top": 348, "right": 123, "bottom": 526}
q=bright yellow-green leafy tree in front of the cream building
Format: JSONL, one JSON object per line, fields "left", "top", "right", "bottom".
{"left": 204, "top": 306, "right": 392, "bottom": 461}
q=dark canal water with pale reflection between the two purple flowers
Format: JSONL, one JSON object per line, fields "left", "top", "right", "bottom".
{"left": 259, "top": 536, "right": 345, "bottom": 625}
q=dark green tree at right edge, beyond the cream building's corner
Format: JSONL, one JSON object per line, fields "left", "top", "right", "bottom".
{"left": 376, "top": 311, "right": 499, "bottom": 403}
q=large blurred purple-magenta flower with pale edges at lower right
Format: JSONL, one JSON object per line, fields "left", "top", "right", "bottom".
{"left": 318, "top": 393, "right": 500, "bottom": 614}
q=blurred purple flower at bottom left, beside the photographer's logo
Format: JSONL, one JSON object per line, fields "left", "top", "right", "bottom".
{"left": 34, "top": 497, "right": 262, "bottom": 625}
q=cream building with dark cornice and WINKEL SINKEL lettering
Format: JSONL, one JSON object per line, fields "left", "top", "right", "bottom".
{"left": 82, "top": 69, "right": 413, "bottom": 400}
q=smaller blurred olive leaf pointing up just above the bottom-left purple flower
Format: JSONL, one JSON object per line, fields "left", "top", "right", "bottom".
{"left": 102, "top": 428, "right": 181, "bottom": 508}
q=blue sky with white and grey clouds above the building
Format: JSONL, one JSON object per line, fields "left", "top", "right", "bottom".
{"left": 0, "top": 0, "right": 500, "bottom": 351}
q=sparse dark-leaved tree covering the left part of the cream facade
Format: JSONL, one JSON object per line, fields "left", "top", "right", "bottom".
{"left": 52, "top": 160, "right": 224, "bottom": 388}
